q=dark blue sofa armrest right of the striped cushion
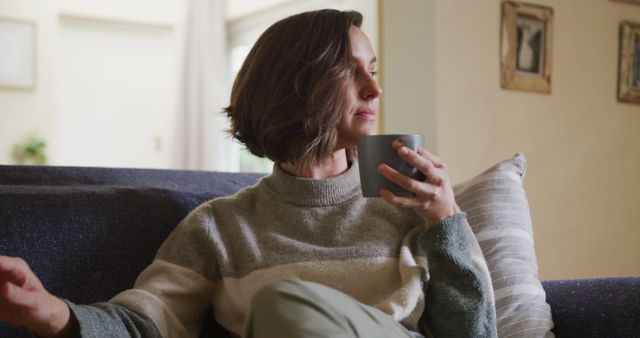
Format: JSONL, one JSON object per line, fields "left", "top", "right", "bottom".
{"left": 542, "top": 277, "right": 640, "bottom": 337}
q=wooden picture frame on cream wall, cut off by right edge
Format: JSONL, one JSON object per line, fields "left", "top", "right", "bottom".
{"left": 618, "top": 21, "right": 640, "bottom": 104}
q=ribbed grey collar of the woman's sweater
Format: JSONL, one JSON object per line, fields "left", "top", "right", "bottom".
{"left": 263, "top": 161, "right": 361, "bottom": 206}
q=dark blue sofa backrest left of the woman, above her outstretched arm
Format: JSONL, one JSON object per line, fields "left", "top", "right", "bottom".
{"left": 0, "top": 166, "right": 261, "bottom": 337}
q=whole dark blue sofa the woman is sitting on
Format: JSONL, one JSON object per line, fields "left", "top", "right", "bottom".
{"left": 0, "top": 166, "right": 640, "bottom": 337}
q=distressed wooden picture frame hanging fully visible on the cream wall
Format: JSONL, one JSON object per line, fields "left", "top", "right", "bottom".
{"left": 500, "top": 1, "right": 553, "bottom": 93}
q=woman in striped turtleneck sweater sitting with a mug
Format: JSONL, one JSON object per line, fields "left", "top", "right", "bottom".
{"left": 0, "top": 10, "right": 496, "bottom": 337}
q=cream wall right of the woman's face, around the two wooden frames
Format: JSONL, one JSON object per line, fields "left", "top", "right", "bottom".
{"left": 383, "top": 0, "right": 640, "bottom": 279}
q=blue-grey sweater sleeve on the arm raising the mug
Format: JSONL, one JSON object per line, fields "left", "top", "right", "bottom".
{"left": 420, "top": 213, "right": 497, "bottom": 337}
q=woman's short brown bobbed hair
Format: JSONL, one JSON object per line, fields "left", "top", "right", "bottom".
{"left": 224, "top": 9, "right": 362, "bottom": 168}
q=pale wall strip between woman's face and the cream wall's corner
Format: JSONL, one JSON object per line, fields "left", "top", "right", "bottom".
{"left": 379, "top": 0, "right": 438, "bottom": 146}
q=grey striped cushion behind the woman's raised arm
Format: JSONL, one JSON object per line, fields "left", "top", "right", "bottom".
{"left": 454, "top": 153, "right": 553, "bottom": 337}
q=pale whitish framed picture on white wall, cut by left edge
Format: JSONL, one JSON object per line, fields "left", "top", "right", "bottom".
{"left": 0, "top": 17, "right": 36, "bottom": 89}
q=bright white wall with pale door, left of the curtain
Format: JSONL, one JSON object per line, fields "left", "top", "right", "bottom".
{"left": 0, "top": 0, "right": 186, "bottom": 167}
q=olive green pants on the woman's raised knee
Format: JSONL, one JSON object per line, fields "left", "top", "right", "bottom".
{"left": 244, "top": 280, "right": 422, "bottom": 338}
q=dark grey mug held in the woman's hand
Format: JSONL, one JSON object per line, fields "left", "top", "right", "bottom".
{"left": 358, "top": 134, "right": 425, "bottom": 197}
